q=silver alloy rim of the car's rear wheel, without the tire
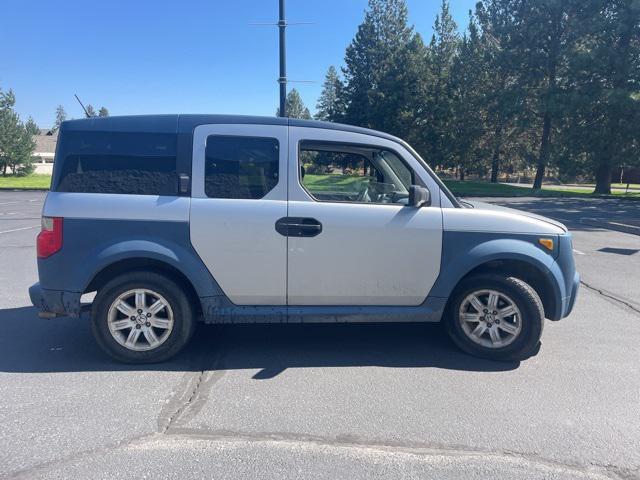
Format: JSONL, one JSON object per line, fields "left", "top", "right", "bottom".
{"left": 107, "top": 288, "right": 174, "bottom": 352}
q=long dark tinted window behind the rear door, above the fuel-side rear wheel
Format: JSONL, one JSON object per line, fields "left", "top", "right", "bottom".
{"left": 56, "top": 131, "right": 178, "bottom": 195}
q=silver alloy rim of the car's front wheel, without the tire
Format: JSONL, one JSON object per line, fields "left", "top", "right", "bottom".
{"left": 458, "top": 289, "right": 522, "bottom": 349}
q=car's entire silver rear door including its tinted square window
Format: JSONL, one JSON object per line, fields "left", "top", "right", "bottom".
{"left": 190, "top": 124, "right": 287, "bottom": 305}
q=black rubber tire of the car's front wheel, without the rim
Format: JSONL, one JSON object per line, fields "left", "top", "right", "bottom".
{"left": 445, "top": 274, "right": 544, "bottom": 360}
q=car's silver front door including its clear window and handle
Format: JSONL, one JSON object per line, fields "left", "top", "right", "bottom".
{"left": 287, "top": 127, "right": 442, "bottom": 306}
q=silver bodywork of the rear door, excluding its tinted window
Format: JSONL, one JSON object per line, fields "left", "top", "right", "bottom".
{"left": 190, "top": 124, "right": 288, "bottom": 305}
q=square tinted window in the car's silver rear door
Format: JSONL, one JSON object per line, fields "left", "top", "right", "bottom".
{"left": 204, "top": 135, "right": 280, "bottom": 200}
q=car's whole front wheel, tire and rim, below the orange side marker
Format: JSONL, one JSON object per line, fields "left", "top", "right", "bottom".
{"left": 445, "top": 275, "right": 544, "bottom": 360}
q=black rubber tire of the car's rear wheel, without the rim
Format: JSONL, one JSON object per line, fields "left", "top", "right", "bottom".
{"left": 91, "top": 271, "right": 195, "bottom": 364}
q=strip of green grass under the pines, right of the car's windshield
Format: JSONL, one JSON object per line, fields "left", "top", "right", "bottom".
{"left": 444, "top": 180, "right": 640, "bottom": 200}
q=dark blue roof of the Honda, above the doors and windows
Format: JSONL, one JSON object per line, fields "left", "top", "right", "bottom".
{"left": 62, "top": 114, "right": 401, "bottom": 142}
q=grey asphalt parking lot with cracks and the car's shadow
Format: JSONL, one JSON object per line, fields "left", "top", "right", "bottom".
{"left": 0, "top": 192, "right": 640, "bottom": 479}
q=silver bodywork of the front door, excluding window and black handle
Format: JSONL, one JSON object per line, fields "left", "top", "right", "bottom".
{"left": 287, "top": 127, "right": 442, "bottom": 306}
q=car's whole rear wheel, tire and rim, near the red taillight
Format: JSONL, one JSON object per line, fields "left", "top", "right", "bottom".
{"left": 92, "top": 272, "right": 194, "bottom": 363}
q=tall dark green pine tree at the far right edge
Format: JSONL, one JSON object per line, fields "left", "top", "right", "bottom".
{"left": 566, "top": 0, "right": 640, "bottom": 194}
